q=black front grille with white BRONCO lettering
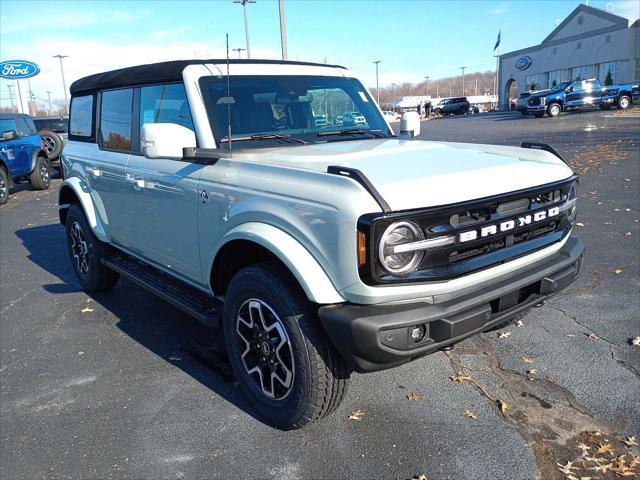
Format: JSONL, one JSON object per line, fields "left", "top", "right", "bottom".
{"left": 358, "top": 178, "right": 574, "bottom": 284}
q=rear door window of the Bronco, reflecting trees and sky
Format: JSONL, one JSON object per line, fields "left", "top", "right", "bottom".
{"left": 99, "top": 88, "right": 133, "bottom": 151}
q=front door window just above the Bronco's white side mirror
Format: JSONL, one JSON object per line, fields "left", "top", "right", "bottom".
{"left": 140, "top": 83, "right": 194, "bottom": 133}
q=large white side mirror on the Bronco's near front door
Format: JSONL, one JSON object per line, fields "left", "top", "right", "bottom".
{"left": 140, "top": 123, "right": 196, "bottom": 160}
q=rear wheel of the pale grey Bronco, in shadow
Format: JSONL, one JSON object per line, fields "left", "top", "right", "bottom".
{"left": 65, "top": 205, "right": 120, "bottom": 292}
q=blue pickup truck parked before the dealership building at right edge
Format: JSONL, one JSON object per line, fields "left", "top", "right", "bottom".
{"left": 527, "top": 78, "right": 640, "bottom": 118}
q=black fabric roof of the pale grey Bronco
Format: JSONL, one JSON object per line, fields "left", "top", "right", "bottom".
{"left": 69, "top": 58, "right": 344, "bottom": 95}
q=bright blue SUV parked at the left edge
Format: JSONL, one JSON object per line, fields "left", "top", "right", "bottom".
{"left": 0, "top": 113, "right": 51, "bottom": 205}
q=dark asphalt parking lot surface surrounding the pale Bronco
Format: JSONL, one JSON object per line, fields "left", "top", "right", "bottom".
{"left": 0, "top": 110, "right": 640, "bottom": 480}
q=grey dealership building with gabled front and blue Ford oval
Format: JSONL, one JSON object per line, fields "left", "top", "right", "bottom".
{"left": 498, "top": 5, "right": 640, "bottom": 108}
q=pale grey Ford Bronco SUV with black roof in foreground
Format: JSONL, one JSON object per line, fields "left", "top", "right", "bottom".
{"left": 59, "top": 60, "right": 584, "bottom": 429}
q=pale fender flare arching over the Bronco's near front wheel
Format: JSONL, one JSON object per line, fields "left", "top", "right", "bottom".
{"left": 209, "top": 222, "right": 345, "bottom": 304}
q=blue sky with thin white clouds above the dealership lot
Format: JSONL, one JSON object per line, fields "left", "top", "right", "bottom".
{"left": 0, "top": 0, "right": 640, "bottom": 106}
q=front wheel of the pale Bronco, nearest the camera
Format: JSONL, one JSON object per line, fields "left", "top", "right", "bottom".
{"left": 223, "top": 263, "right": 349, "bottom": 430}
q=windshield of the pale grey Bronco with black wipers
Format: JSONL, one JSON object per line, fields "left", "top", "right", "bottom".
{"left": 200, "top": 75, "right": 392, "bottom": 147}
